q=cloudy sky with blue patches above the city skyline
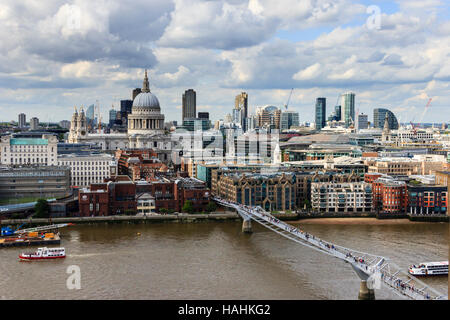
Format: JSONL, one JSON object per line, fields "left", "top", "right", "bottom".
{"left": 0, "top": 0, "right": 450, "bottom": 122}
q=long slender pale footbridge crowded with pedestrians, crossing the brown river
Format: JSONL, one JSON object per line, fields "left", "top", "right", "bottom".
{"left": 213, "top": 197, "right": 447, "bottom": 300}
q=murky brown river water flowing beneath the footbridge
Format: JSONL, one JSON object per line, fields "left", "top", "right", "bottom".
{"left": 0, "top": 219, "right": 449, "bottom": 299}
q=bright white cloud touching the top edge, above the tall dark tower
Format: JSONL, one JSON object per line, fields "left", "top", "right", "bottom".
{"left": 158, "top": 0, "right": 276, "bottom": 49}
